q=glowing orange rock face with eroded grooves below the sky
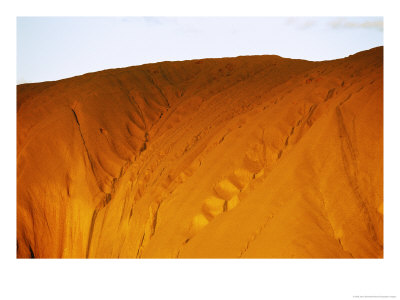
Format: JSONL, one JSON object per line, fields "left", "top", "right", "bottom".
{"left": 17, "top": 47, "right": 383, "bottom": 258}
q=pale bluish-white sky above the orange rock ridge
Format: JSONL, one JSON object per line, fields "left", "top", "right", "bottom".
{"left": 17, "top": 17, "right": 383, "bottom": 84}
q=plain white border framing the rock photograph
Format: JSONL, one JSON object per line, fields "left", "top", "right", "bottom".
{"left": 0, "top": 0, "right": 400, "bottom": 299}
